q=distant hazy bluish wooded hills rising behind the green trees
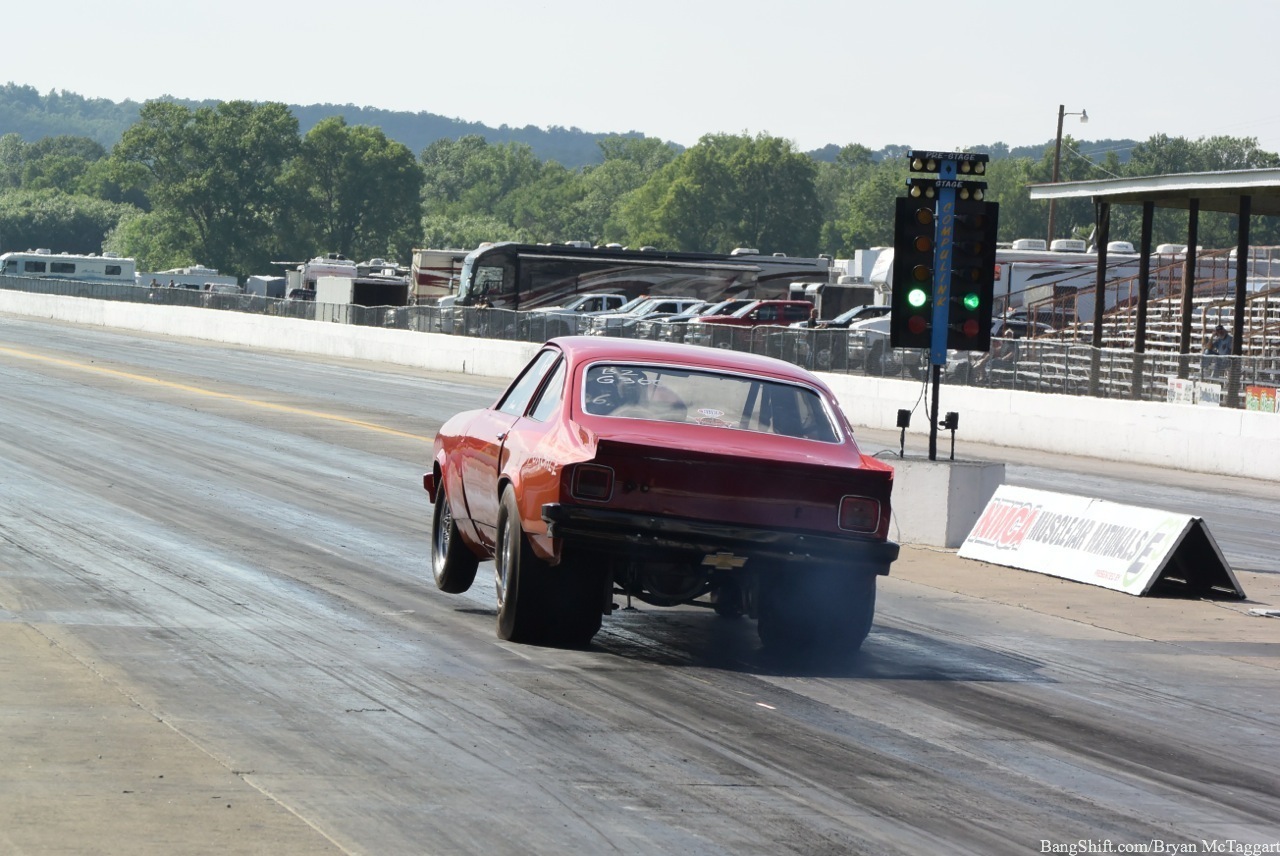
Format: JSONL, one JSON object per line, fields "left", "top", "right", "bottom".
{"left": 0, "top": 83, "right": 1135, "bottom": 169}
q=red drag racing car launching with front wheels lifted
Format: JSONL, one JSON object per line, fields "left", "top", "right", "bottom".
{"left": 422, "top": 337, "right": 899, "bottom": 651}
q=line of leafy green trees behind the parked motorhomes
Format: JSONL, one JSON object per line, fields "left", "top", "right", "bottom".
{"left": 0, "top": 95, "right": 1280, "bottom": 276}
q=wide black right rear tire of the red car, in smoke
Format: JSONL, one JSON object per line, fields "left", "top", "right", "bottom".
{"left": 756, "top": 572, "right": 876, "bottom": 655}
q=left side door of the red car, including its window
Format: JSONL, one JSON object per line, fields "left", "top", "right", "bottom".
{"left": 458, "top": 348, "right": 559, "bottom": 539}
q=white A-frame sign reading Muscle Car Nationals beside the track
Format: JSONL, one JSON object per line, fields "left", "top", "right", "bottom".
{"left": 960, "top": 485, "right": 1244, "bottom": 599}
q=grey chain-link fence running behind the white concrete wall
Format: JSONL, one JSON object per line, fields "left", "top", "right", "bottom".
{"left": 0, "top": 276, "right": 1280, "bottom": 408}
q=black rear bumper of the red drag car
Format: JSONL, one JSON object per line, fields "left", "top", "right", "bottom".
{"left": 543, "top": 503, "right": 899, "bottom": 576}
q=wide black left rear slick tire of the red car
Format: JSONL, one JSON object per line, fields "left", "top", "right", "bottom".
{"left": 494, "top": 487, "right": 607, "bottom": 647}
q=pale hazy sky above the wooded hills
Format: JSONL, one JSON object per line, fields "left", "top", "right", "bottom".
{"left": 10, "top": 0, "right": 1280, "bottom": 165}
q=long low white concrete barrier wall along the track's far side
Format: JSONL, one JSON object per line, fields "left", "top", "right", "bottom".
{"left": 0, "top": 289, "right": 1280, "bottom": 479}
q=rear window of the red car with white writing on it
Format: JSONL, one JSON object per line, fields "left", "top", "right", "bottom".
{"left": 582, "top": 363, "right": 840, "bottom": 443}
